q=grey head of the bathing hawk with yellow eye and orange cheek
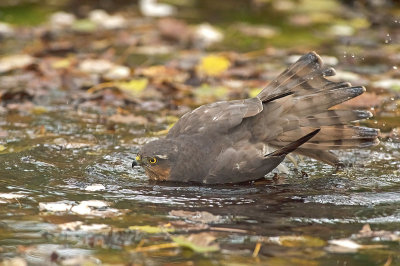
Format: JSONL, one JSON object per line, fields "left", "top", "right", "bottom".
{"left": 132, "top": 139, "right": 178, "bottom": 181}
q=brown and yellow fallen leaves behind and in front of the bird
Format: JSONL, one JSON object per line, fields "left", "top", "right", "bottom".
{"left": 0, "top": 1, "right": 400, "bottom": 265}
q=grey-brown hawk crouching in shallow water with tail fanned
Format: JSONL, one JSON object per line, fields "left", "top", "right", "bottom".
{"left": 132, "top": 52, "right": 379, "bottom": 185}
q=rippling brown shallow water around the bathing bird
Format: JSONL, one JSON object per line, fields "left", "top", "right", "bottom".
{"left": 0, "top": 108, "right": 400, "bottom": 265}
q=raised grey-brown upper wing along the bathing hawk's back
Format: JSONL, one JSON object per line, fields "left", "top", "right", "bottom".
{"left": 167, "top": 98, "right": 263, "bottom": 138}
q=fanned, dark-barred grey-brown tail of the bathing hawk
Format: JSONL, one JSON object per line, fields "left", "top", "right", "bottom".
{"left": 253, "top": 52, "right": 379, "bottom": 165}
